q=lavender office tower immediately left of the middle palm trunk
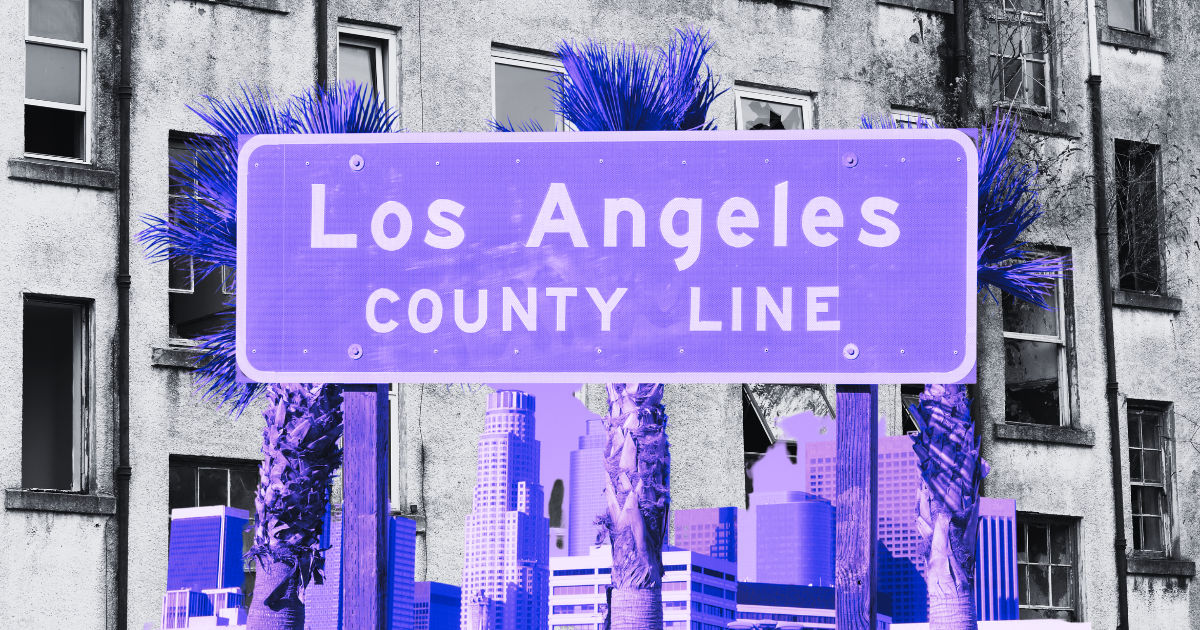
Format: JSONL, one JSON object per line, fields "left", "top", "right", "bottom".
{"left": 566, "top": 418, "right": 608, "bottom": 556}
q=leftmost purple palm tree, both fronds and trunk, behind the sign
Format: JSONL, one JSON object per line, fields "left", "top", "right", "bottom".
{"left": 138, "top": 82, "right": 397, "bottom": 630}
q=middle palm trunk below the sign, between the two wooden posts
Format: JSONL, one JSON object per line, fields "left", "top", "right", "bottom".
{"left": 598, "top": 383, "right": 671, "bottom": 630}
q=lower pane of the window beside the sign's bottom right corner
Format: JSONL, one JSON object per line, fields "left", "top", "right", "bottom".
{"left": 1004, "top": 340, "right": 1061, "bottom": 425}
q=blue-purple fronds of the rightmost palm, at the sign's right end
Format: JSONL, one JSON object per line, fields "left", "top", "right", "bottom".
{"left": 860, "top": 109, "right": 1070, "bottom": 310}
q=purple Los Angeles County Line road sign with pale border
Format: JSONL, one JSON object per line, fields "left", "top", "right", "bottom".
{"left": 236, "top": 130, "right": 978, "bottom": 383}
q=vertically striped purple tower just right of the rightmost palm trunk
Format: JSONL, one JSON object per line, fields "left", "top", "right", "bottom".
{"left": 976, "top": 497, "right": 1019, "bottom": 622}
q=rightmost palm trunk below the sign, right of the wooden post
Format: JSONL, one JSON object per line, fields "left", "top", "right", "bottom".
{"left": 912, "top": 385, "right": 989, "bottom": 630}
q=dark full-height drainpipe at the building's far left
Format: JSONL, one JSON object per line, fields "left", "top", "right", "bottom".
{"left": 116, "top": 0, "right": 133, "bottom": 630}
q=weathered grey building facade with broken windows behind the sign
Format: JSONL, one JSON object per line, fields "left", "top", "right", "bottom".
{"left": 0, "top": 0, "right": 1200, "bottom": 630}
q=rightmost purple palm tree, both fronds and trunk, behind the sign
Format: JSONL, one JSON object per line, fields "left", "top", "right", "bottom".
{"left": 863, "top": 110, "right": 1068, "bottom": 630}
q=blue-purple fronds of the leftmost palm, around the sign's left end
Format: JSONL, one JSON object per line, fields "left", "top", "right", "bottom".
{"left": 137, "top": 82, "right": 398, "bottom": 414}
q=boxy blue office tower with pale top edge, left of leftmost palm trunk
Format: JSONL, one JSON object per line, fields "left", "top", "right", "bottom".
{"left": 167, "top": 505, "right": 250, "bottom": 590}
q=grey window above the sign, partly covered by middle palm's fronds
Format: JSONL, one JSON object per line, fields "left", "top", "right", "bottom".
{"left": 492, "top": 49, "right": 566, "bottom": 131}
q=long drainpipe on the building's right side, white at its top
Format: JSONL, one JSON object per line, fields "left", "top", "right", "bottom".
{"left": 1087, "top": 0, "right": 1129, "bottom": 630}
